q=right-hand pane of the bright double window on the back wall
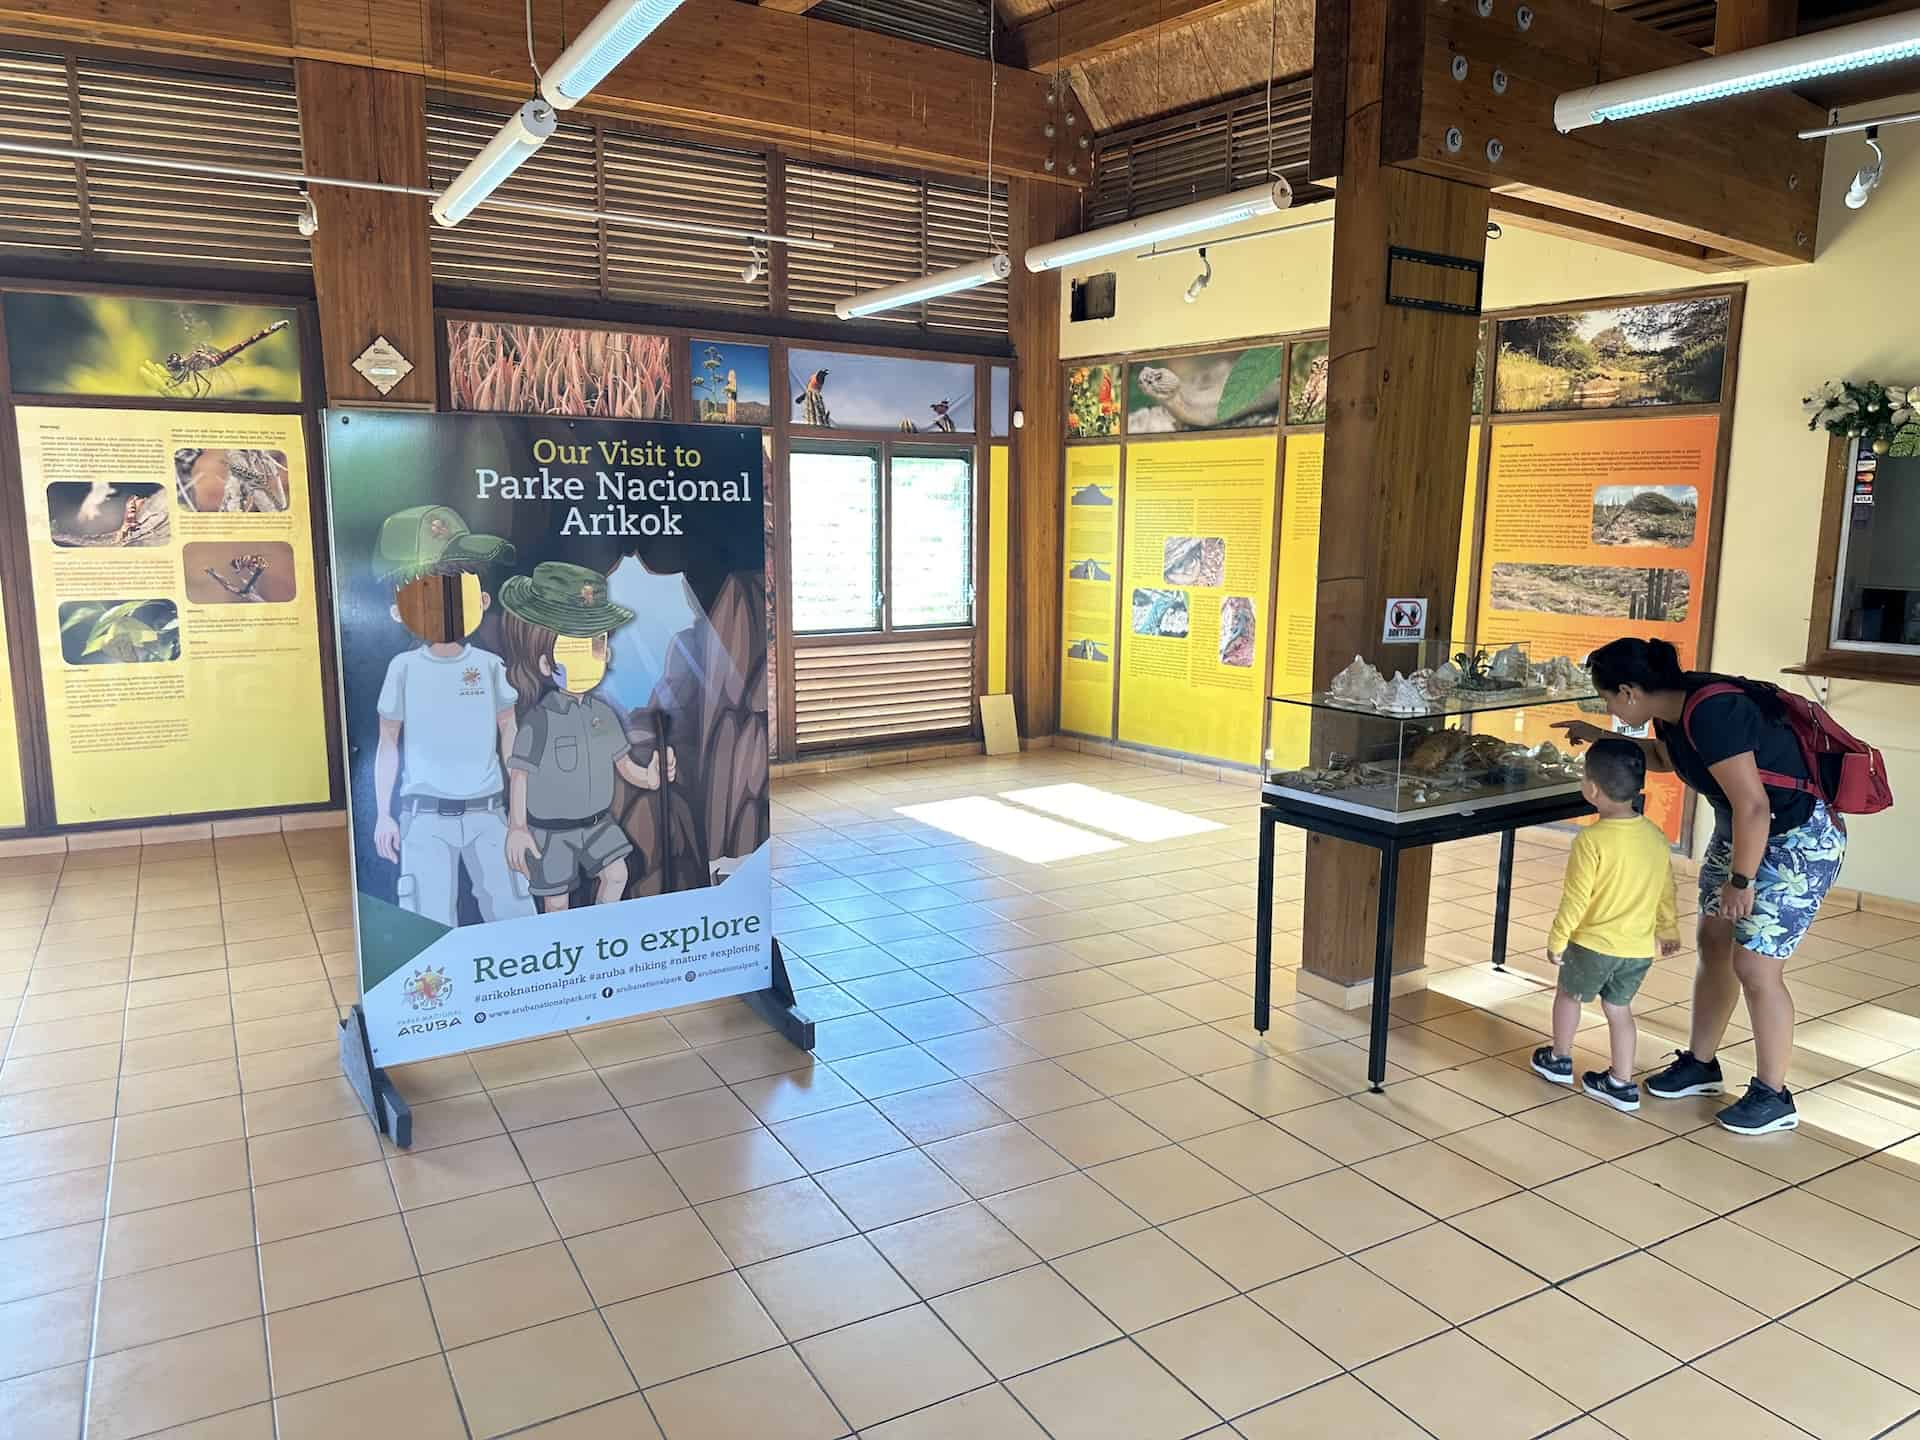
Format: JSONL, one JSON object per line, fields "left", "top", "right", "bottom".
{"left": 889, "top": 451, "right": 973, "bottom": 630}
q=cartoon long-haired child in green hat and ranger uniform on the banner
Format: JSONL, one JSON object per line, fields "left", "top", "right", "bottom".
{"left": 499, "top": 561, "right": 676, "bottom": 912}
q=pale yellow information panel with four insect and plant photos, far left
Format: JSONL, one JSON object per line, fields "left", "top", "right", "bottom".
{"left": 17, "top": 407, "right": 328, "bottom": 824}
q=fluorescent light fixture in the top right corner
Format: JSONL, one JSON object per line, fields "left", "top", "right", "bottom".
{"left": 1553, "top": 10, "right": 1920, "bottom": 132}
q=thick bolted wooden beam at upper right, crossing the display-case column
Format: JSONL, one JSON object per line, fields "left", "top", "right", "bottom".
{"left": 1311, "top": 0, "right": 1824, "bottom": 265}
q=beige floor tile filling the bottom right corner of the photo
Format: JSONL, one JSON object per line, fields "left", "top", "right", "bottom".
{"left": 1699, "top": 1325, "right": 1920, "bottom": 1440}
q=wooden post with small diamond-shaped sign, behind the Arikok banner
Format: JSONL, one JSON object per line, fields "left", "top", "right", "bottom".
{"left": 296, "top": 60, "right": 436, "bottom": 409}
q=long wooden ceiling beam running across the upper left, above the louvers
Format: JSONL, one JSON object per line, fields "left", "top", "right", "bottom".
{"left": 0, "top": 0, "right": 1077, "bottom": 188}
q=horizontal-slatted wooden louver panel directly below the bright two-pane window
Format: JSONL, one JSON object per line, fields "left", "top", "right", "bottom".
{"left": 793, "top": 634, "right": 973, "bottom": 751}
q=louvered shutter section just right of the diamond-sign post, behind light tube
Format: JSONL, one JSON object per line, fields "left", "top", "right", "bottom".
{"left": 426, "top": 102, "right": 603, "bottom": 296}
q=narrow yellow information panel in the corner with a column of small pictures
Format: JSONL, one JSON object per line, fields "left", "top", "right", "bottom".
{"left": 1060, "top": 445, "right": 1119, "bottom": 739}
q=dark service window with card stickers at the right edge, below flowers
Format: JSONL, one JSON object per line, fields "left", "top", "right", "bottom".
{"left": 1834, "top": 451, "right": 1920, "bottom": 653}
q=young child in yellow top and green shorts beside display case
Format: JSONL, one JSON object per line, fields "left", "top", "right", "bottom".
{"left": 1534, "top": 739, "right": 1680, "bottom": 1110}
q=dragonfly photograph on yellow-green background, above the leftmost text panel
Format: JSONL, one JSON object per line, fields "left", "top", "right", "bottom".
{"left": 6, "top": 290, "right": 300, "bottom": 403}
